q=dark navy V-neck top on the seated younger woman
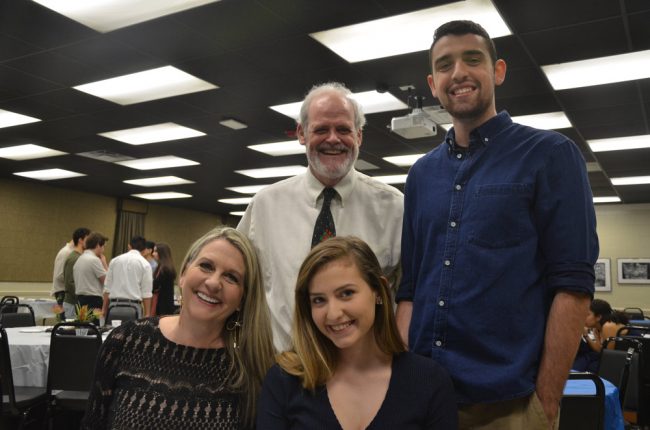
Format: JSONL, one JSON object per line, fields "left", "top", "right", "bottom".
{"left": 257, "top": 352, "right": 458, "bottom": 430}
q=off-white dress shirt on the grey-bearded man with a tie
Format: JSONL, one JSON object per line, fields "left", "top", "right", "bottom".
{"left": 237, "top": 169, "right": 404, "bottom": 351}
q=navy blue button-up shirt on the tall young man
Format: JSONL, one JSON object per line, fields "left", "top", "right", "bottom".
{"left": 397, "top": 112, "right": 598, "bottom": 403}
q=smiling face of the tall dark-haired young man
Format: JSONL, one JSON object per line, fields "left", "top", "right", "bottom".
{"left": 427, "top": 34, "right": 506, "bottom": 127}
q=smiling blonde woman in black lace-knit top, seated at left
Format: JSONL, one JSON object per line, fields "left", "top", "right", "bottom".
{"left": 82, "top": 227, "right": 274, "bottom": 430}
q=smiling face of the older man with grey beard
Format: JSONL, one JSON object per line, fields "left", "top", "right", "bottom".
{"left": 297, "top": 91, "right": 362, "bottom": 186}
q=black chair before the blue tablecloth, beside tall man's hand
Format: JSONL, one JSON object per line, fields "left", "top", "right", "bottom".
{"left": 559, "top": 373, "right": 605, "bottom": 430}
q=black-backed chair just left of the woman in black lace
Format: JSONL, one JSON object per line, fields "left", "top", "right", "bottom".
{"left": 46, "top": 322, "right": 102, "bottom": 423}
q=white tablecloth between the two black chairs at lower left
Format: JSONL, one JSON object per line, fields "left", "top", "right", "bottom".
{"left": 5, "top": 326, "right": 50, "bottom": 387}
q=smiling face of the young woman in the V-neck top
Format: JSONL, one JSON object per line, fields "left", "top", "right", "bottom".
{"left": 309, "top": 258, "right": 377, "bottom": 351}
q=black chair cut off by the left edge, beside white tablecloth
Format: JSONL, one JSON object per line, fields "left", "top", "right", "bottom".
{"left": 0, "top": 326, "right": 47, "bottom": 429}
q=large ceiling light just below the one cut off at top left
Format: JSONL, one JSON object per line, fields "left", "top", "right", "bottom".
{"left": 74, "top": 66, "right": 219, "bottom": 105}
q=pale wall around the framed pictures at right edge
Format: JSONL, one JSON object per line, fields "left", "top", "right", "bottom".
{"left": 596, "top": 204, "right": 650, "bottom": 314}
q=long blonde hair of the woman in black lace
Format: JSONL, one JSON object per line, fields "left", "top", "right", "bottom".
{"left": 181, "top": 226, "right": 275, "bottom": 428}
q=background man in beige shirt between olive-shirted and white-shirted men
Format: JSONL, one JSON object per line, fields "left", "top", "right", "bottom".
{"left": 73, "top": 232, "right": 108, "bottom": 309}
